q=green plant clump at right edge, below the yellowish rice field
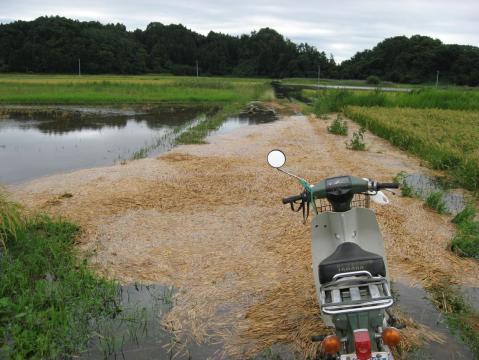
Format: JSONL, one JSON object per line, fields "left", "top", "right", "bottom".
{"left": 451, "top": 204, "right": 479, "bottom": 259}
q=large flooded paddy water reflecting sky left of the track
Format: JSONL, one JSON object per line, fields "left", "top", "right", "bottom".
{"left": 0, "top": 107, "right": 276, "bottom": 184}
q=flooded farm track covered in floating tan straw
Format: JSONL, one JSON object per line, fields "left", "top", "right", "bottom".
{"left": 10, "top": 116, "right": 479, "bottom": 358}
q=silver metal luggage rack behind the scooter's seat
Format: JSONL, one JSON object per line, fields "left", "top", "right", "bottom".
{"left": 320, "top": 271, "right": 394, "bottom": 315}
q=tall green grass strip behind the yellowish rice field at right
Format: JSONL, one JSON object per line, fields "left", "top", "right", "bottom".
{"left": 314, "top": 88, "right": 479, "bottom": 115}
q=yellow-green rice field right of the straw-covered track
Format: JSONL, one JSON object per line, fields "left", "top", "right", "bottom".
{"left": 344, "top": 106, "right": 479, "bottom": 190}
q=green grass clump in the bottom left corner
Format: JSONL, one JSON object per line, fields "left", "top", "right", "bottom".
{"left": 0, "top": 197, "right": 119, "bottom": 359}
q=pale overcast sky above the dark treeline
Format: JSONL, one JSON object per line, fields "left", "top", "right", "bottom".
{"left": 0, "top": 0, "right": 479, "bottom": 61}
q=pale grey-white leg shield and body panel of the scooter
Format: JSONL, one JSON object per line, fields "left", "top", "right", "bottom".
{"left": 311, "top": 208, "right": 388, "bottom": 326}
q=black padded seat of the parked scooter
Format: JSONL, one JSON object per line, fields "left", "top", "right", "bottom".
{"left": 318, "top": 242, "right": 386, "bottom": 284}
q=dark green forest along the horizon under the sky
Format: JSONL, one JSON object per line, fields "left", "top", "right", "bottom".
{"left": 0, "top": 16, "right": 479, "bottom": 86}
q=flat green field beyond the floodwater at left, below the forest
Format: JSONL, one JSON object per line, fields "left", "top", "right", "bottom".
{"left": 0, "top": 75, "right": 269, "bottom": 104}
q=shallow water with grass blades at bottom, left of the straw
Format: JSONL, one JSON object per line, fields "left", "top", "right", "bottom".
{"left": 80, "top": 284, "right": 219, "bottom": 360}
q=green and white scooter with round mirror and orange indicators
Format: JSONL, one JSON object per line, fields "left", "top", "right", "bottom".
{"left": 268, "top": 150, "right": 401, "bottom": 360}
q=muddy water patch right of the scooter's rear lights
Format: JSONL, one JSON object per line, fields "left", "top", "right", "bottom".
{"left": 392, "top": 282, "right": 474, "bottom": 360}
